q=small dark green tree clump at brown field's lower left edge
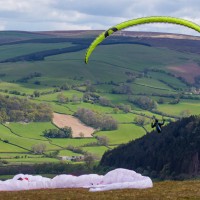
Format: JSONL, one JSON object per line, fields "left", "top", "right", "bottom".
{"left": 43, "top": 126, "right": 72, "bottom": 138}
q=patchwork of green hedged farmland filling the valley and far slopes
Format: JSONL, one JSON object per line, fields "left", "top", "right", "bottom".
{"left": 0, "top": 32, "right": 200, "bottom": 165}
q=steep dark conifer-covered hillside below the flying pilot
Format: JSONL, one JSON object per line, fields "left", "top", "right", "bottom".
{"left": 100, "top": 116, "right": 200, "bottom": 179}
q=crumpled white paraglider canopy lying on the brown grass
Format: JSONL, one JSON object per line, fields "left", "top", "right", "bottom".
{"left": 0, "top": 168, "right": 153, "bottom": 192}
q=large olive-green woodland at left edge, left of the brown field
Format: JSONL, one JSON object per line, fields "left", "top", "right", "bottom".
{"left": 0, "top": 95, "right": 53, "bottom": 123}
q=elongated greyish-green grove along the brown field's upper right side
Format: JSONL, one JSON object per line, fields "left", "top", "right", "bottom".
{"left": 75, "top": 108, "right": 118, "bottom": 131}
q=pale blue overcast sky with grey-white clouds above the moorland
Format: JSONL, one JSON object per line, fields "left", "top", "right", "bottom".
{"left": 0, "top": 0, "right": 200, "bottom": 35}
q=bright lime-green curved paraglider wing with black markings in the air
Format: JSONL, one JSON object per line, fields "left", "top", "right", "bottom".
{"left": 85, "top": 16, "right": 200, "bottom": 64}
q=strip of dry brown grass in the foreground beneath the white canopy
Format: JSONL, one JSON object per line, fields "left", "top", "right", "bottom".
{"left": 0, "top": 181, "right": 200, "bottom": 200}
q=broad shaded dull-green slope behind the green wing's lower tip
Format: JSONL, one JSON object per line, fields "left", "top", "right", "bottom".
{"left": 0, "top": 45, "right": 199, "bottom": 84}
